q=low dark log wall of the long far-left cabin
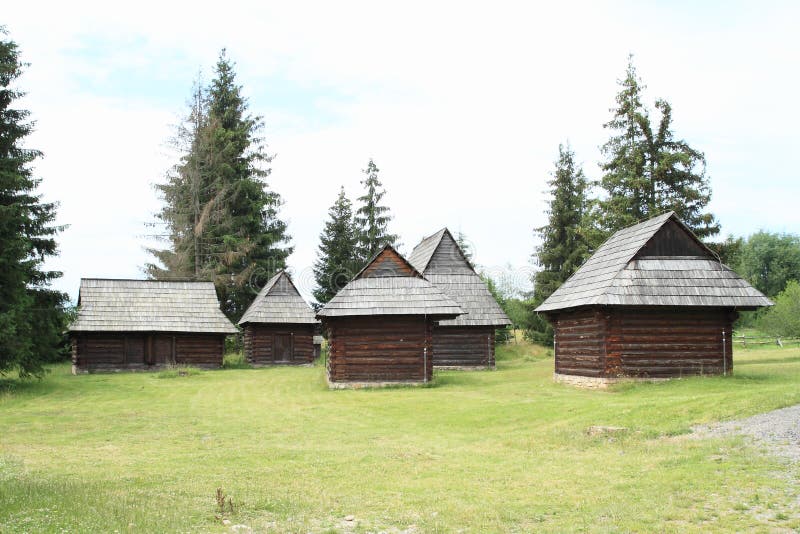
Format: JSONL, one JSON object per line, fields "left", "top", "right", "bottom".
{"left": 71, "top": 332, "right": 225, "bottom": 371}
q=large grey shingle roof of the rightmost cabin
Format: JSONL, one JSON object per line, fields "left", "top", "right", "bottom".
{"left": 536, "top": 212, "right": 772, "bottom": 312}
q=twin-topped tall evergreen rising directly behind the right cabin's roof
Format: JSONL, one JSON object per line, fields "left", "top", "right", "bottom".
{"left": 598, "top": 57, "right": 719, "bottom": 238}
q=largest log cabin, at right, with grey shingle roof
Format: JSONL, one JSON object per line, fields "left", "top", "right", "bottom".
{"left": 536, "top": 212, "right": 772, "bottom": 387}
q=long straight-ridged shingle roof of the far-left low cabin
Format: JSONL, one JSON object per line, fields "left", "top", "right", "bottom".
{"left": 69, "top": 278, "right": 238, "bottom": 334}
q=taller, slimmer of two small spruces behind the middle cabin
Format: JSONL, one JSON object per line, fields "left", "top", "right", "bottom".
{"left": 355, "top": 158, "right": 397, "bottom": 263}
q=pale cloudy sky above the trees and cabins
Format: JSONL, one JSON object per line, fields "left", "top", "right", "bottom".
{"left": 0, "top": 1, "right": 800, "bottom": 299}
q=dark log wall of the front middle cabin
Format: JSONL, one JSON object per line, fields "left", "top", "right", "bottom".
{"left": 326, "top": 316, "right": 433, "bottom": 383}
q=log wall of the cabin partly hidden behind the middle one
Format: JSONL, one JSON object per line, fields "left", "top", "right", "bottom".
{"left": 432, "top": 326, "right": 494, "bottom": 367}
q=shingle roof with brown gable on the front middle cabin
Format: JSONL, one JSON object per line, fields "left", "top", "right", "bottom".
{"left": 317, "top": 245, "right": 463, "bottom": 318}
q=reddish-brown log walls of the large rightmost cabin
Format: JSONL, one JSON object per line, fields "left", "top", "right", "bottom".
{"left": 551, "top": 307, "right": 736, "bottom": 378}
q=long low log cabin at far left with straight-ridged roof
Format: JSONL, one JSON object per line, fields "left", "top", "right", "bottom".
{"left": 69, "top": 278, "right": 238, "bottom": 374}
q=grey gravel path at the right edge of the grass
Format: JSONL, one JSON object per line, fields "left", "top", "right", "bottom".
{"left": 692, "top": 404, "right": 800, "bottom": 463}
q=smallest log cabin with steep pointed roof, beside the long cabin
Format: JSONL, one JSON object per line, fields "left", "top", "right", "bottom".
{"left": 239, "top": 271, "right": 319, "bottom": 366}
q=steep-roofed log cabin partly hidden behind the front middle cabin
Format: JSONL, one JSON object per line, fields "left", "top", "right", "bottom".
{"left": 408, "top": 228, "right": 511, "bottom": 369}
